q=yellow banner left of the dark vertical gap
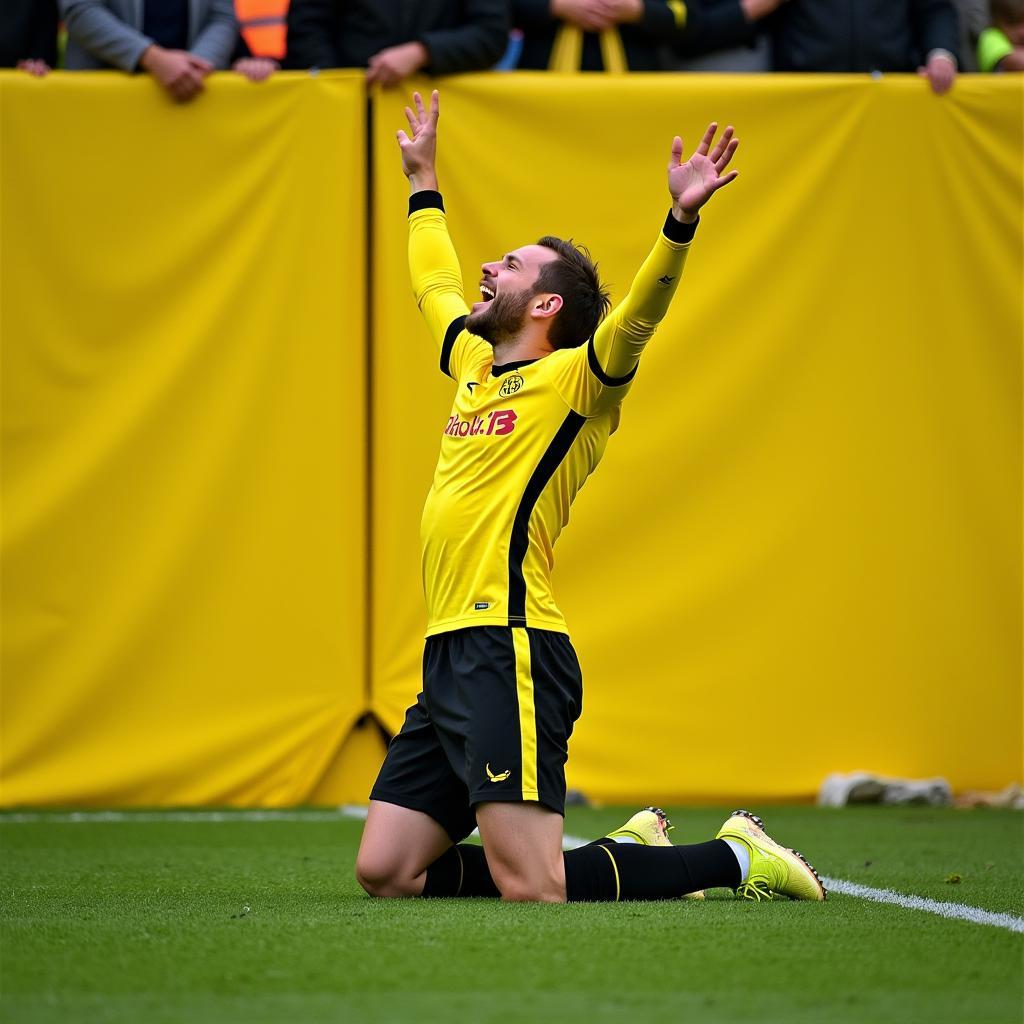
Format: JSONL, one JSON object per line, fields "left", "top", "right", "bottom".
{"left": 0, "top": 73, "right": 367, "bottom": 805}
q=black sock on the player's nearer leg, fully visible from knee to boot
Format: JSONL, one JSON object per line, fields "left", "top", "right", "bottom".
{"left": 564, "top": 839, "right": 740, "bottom": 903}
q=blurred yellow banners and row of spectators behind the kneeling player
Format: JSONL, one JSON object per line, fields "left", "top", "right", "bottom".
{"left": 0, "top": 0, "right": 1024, "bottom": 807}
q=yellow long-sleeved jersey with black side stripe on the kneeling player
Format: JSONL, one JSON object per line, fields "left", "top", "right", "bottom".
{"left": 409, "top": 191, "right": 695, "bottom": 636}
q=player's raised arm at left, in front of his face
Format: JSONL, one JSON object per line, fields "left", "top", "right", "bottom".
{"left": 397, "top": 89, "right": 469, "bottom": 364}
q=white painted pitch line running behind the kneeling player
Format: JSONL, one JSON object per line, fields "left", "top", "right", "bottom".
{"left": 0, "top": 804, "right": 1024, "bottom": 932}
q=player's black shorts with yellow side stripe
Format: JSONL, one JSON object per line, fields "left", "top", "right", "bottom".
{"left": 370, "top": 626, "right": 583, "bottom": 843}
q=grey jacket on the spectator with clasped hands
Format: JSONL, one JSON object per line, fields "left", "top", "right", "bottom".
{"left": 58, "top": 0, "right": 239, "bottom": 71}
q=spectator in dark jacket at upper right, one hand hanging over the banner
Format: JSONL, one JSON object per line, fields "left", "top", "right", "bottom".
{"left": 770, "top": 0, "right": 958, "bottom": 94}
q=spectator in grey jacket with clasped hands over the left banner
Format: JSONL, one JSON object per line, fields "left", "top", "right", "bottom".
{"left": 59, "top": 0, "right": 238, "bottom": 102}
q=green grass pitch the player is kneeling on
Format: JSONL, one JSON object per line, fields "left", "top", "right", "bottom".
{"left": 0, "top": 808, "right": 1024, "bottom": 1024}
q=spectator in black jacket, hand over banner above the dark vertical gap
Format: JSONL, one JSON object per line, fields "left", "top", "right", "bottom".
{"left": 286, "top": 0, "right": 509, "bottom": 88}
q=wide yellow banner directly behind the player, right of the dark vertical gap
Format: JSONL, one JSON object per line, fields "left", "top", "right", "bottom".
{"left": 371, "top": 74, "right": 1024, "bottom": 802}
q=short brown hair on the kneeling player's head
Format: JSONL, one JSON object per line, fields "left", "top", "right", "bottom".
{"left": 534, "top": 234, "right": 611, "bottom": 348}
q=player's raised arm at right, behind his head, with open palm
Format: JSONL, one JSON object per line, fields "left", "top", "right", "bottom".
{"left": 591, "top": 123, "right": 739, "bottom": 387}
